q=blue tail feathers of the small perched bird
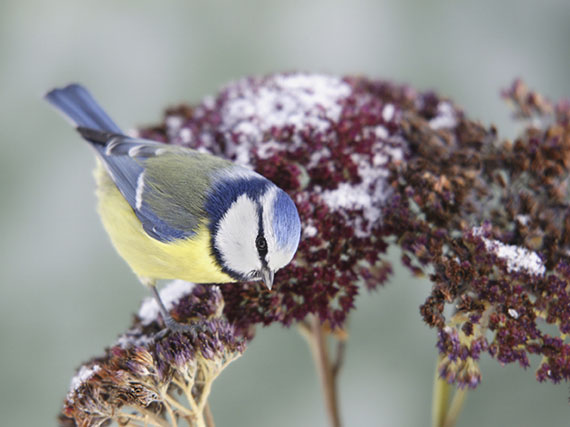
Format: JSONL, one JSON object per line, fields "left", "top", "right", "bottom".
{"left": 45, "top": 83, "right": 121, "bottom": 133}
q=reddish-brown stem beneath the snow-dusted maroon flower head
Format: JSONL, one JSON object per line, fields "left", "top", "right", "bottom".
{"left": 305, "top": 316, "right": 343, "bottom": 427}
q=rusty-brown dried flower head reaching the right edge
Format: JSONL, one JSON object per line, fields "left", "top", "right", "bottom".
{"left": 385, "top": 81, "right": 570, "bottom": 387}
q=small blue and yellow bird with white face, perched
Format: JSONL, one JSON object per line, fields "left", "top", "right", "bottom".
{"left": 45, "top": 83, "right": 301, "bottom": 331}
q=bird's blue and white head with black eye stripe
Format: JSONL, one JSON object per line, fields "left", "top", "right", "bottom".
{"left": 207, "top": 174, "right": 301, "bottom": 289}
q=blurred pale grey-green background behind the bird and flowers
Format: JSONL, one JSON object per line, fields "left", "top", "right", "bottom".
{"left": 0, "top": 0, "right": 570, "bottom": 427}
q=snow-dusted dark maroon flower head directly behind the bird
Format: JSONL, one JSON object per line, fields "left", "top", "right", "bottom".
{"left": 140, "top": 73, "right": 413, "bottom": 333}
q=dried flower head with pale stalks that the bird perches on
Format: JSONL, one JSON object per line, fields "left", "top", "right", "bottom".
{"left": 60, "top": 281, "right": 245, "bottom": 426}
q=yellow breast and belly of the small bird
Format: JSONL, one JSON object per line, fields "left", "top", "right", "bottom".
{"left": 95, "top": 162, "right": 235, "bottom": 283}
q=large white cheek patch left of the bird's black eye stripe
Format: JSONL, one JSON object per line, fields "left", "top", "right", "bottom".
{"left": 215, "top": 194, "right": 261, "bottom": 274}
